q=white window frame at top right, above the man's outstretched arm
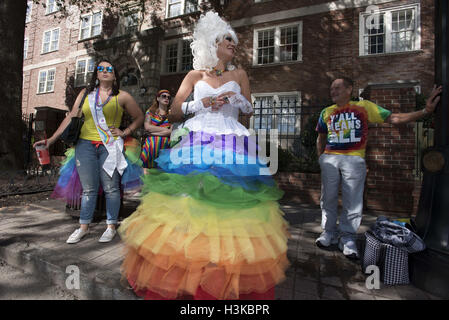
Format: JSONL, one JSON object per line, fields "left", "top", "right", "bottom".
{"left": 359, "top": 3, "right": 421, "bottom": 57}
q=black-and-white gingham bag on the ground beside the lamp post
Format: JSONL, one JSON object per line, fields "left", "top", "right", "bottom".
{"left": 363, "top": 231, "right": 410, "bottom": 285}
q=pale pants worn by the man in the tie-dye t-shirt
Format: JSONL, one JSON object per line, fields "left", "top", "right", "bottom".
{"left": 319, "top": 153, "right": 366, "bottom": 237}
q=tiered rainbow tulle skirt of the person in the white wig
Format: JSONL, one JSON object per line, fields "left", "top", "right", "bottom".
{"left": 118, "top": 132, "right": 289, "bottom": 300}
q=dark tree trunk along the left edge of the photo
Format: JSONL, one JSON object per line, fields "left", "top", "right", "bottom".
{"left": 0, "top": 0, "right": 27, "bottom": 171}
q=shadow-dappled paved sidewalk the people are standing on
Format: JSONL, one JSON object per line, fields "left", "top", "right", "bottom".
{"left": 0, "top": 200, "right": 439, "bottom": 300}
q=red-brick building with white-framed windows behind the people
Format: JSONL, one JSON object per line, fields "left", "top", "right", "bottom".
{"left": 22, "top": 0, "right": 434, "bottom": 215}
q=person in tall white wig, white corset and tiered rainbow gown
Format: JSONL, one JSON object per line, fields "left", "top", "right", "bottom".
{"left": 118, "top": 12, "right": 289, "bottom": 300}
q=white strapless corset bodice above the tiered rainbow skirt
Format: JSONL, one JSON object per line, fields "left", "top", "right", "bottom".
{"left": 184, "top": 80, "right": 250, "bottom": 136}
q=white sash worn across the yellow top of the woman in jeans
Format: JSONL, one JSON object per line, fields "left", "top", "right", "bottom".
{"left": 88, "top": 91, "right": 128, "bottom": 178}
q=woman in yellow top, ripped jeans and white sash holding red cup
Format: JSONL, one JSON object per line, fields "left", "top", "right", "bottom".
{"left": 34, "top": 60, "right": 144, "bottom": 243}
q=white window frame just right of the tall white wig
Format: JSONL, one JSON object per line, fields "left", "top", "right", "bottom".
{"left": 253, "top": 20, "right": 303, "bottom": 66}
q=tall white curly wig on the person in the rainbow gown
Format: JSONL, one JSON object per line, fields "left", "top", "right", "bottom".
{"left": 190, "top": 11, "right": 238, "bottom": 70}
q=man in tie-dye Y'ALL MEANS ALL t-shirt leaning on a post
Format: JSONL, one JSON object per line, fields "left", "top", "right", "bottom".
{"left": 316, "top": 77, "right": 442, "bottom": 258}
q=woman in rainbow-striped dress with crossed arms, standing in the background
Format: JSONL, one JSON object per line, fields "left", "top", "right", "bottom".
{"left": 140, "top": 90, "right": 172, "bottom": 173}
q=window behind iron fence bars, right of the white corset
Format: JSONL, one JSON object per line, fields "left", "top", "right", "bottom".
{"left": 251, "top": 92, "right": 301, "bottom": 134}
